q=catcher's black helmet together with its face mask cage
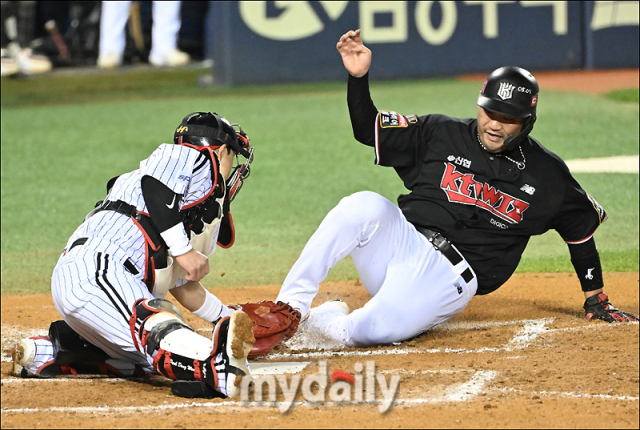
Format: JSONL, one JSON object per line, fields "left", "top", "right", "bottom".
{"left": 173, "top": 112, "right": 253, "bottom": 201}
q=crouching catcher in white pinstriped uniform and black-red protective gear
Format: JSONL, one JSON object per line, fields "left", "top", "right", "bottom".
{"left": 13, "top": 112, "right": 262, "bottom": 398}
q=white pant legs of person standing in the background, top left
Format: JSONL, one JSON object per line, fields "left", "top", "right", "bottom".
{"left": 99, "top": 1, "right": 181, "bottom": 57}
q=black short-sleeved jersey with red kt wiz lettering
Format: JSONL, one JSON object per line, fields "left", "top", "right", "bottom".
{"left": 350, "top": 74, "right": 607, "bottom": 294}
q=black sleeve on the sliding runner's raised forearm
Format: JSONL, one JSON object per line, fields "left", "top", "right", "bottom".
{"left": 347, "top": 73, "right": 378, "bottom": 146}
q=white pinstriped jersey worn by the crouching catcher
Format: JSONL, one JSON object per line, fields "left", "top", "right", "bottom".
{"left": 66, "top": 143, "right": 217, "bottom": 286}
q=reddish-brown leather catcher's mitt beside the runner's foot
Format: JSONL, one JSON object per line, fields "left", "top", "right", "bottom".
{"left": 230, "top": 300, "right": 301, "bottom": 358}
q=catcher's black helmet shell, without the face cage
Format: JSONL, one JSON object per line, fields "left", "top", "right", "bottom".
{"left": 173, "top": 112, "right": 250, "bottom": 158}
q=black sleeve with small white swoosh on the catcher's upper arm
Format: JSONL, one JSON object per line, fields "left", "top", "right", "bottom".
{"left": 141, "top": 175, "right": 182, "bottom": 233}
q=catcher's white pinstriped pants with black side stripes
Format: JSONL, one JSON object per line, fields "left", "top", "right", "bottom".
{"left": 51, "top": 239, "right": 153, "bottom": 374}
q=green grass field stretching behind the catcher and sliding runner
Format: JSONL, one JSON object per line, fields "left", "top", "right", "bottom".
{"left": 1, "top": 70, "right": 638, "bottom": 294}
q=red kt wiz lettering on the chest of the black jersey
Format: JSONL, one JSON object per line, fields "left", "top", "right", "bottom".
{"left": 440, "top": 163, "right": 529, "bottom": 224}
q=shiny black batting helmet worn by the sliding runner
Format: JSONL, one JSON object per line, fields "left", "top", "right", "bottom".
{"left": 478, "top": 66, "right": 539, "bottom": 150}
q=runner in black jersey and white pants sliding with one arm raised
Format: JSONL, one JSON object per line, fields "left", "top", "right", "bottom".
{"left": 277, "top": 30, "right": 638, "bottom": 346}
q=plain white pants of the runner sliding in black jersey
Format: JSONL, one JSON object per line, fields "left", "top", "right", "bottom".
{"left": 277, "top": 191, "right": 478, "bottom": 346}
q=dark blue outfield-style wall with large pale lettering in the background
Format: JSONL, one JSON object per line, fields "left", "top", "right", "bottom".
{"left": 207, "top": 1, "right": 639, "bottom": 85}
